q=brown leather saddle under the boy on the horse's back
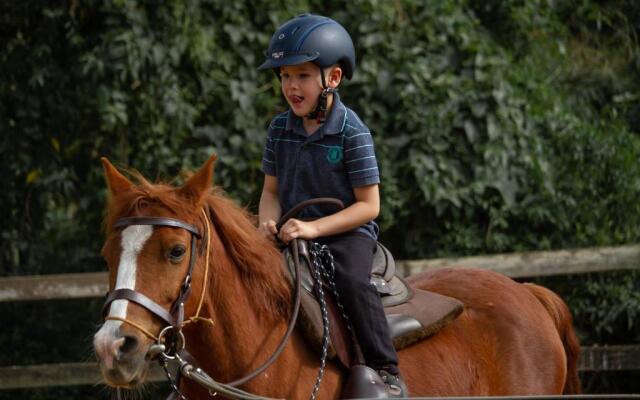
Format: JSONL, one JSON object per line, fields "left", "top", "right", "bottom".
{"left": 283, "top": 240, "right": 463, "bottom": 367}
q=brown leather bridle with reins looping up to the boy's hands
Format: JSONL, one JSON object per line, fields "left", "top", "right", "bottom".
{"left": 102, "top": 198, "right": 344, "bottom": 400}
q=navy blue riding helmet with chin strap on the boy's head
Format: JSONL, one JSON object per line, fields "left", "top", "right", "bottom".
{"left": 258, "top": 14, "right": 356, "bottom": 122}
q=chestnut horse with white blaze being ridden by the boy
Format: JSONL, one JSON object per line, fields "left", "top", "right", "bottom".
{"left": 94, "top": 157, "right": 580, "bottom": 399}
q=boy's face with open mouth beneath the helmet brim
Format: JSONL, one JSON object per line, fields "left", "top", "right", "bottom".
{"left": 280, "top": 62, "right": 322, "bottom": 117}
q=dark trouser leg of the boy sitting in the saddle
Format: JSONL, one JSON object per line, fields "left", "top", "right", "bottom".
{"left": 316, "top": 232, "right": 398, "bottom": 374}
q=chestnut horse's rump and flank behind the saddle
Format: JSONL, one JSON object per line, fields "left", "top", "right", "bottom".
{"left": 400, "top": 269, "right": 575, "bottom": 396}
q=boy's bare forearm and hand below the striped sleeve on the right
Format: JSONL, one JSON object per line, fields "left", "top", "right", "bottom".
{"left": 276, "top": 184, "right": 380, "bottom": 243}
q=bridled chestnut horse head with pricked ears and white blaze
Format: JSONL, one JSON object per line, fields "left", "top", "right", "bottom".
{"left": 93, "top": 156, "right": 215, "bottom": 388}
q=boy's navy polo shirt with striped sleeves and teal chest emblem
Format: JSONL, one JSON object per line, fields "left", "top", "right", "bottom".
{"left": 262, "top": 93, "right": 380, "bottom": 239}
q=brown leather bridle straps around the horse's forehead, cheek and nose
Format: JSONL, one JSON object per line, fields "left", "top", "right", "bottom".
{"left": 102, "top": 214, "right": 209, "bottom": 340}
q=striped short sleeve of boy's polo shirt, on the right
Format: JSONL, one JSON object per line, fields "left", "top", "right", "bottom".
{"left": 344, "top": 126, "right": 380, "bottom": 187}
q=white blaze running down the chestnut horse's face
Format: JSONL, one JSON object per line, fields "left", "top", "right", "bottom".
{"left": 95, "top": 225, "right": 153, "bottom": 343}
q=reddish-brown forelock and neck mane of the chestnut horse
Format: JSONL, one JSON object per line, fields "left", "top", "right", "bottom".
{"left": 104, "top": 170, "right": 291, "bottom": 319}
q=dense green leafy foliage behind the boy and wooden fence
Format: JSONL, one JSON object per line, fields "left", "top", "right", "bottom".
{"left": 0, "top": 0, "right": 640, "bottom": 394}
